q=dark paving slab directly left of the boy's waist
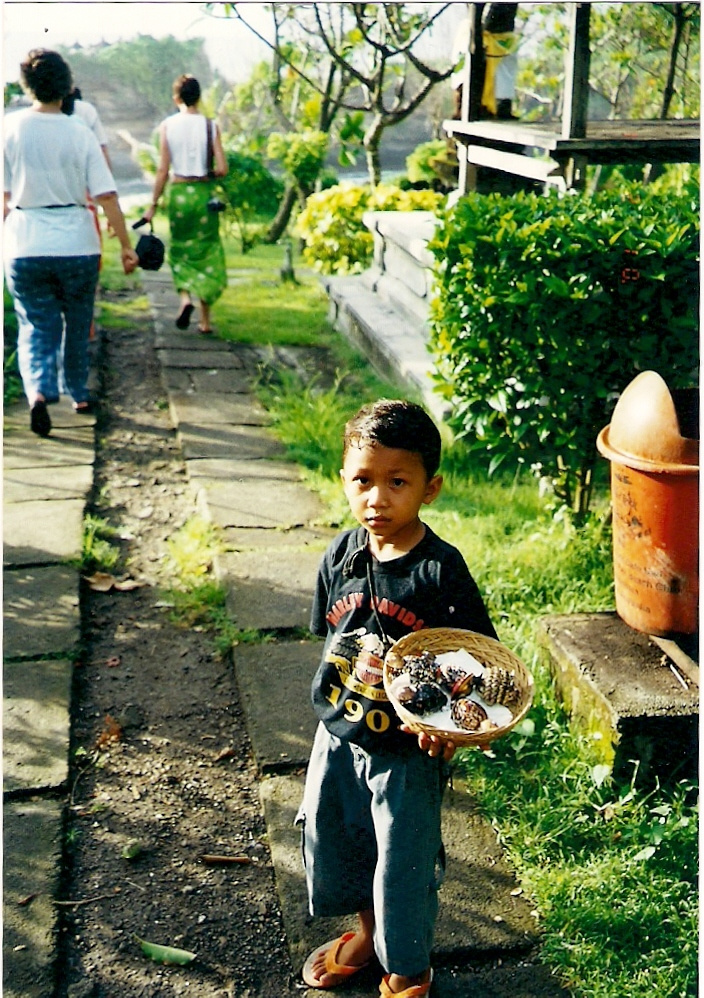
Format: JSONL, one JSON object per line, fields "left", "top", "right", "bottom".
{"left": 233, "top": 640, "right": 323, "bottom": 773}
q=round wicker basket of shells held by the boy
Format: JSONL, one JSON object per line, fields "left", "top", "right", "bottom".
{"left": 384, "top": 627, "right": 533, "bottom": 745}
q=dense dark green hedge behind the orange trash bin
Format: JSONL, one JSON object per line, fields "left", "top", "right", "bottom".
{"left": 430, "top": 185, "right": 699, "bottom": 518}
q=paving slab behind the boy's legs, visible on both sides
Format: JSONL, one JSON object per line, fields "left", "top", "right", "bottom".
{"left": 260, "top": 774, "right": 538, "bottom": 994}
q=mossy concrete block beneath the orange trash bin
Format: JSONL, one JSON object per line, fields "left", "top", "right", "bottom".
{"left": 538, "top": 613, "right": 699, "bottom": 780}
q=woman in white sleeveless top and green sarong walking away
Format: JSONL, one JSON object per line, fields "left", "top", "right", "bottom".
{"left": 144, "top": 76, "right": 227, "bottom": 333}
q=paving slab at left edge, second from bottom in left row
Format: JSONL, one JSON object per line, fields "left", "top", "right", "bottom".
{"left": 2, "top": 659, "right": 73, "bottom": 793}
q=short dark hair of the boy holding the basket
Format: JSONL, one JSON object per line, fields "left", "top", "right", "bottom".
{"left": 342, "top": 399, "right": 442, "bottom": 479}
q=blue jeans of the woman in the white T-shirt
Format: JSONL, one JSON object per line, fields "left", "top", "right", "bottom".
{"left": 6, "top": 255, "right": 100, "bottom": 404}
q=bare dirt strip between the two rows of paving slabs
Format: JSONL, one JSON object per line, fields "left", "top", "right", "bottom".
{"left": 57, "top": 286, "right": 300, "bottom": 998}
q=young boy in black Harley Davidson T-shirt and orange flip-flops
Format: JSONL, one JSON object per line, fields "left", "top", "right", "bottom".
{"left": 297, "top": 399, "right": 496, "bottom": 998}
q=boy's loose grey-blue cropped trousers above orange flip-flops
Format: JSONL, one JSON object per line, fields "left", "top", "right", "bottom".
{"left": 296, "top": 724, "right": 448, "bottom": 977}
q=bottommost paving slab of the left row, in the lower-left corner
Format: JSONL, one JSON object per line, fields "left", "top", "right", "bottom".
{"left": 2, "top": 800, "right": 62, "bottom": 998}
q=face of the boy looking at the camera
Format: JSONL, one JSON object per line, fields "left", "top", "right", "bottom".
{"left": 340, "top": 444, "right": 442, "bottom": 552}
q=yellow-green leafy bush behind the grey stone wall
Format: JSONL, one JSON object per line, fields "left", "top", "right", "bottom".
{"left": 296, "top": 184, "right": 444, "bottom": 274}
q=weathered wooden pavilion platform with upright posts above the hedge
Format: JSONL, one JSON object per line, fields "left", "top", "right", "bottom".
{"left": 443, "top": 3, "right": 700, "bottom": 194}
